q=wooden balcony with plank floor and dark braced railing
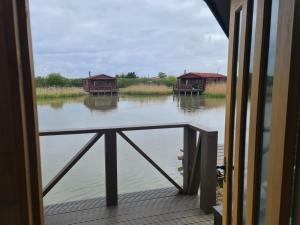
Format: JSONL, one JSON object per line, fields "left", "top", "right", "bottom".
{"left": 40, "top": 123, "right": 218, "bottom": 225}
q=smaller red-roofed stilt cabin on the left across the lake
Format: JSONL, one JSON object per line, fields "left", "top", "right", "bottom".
{"left": 83, "top": 74, "right": 118, "bottom": 95}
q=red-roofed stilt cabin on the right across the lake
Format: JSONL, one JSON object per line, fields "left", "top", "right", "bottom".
{"left": 173, "top": 72, "right": 227, "bottom": 95}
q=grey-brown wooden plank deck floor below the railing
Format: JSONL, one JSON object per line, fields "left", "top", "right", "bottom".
{"left": 45, "top": 188, "right": 213, "bottom": 225}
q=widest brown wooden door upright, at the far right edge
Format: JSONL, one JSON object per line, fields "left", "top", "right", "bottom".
{"left": 266, "top": 0, "right": 300, "bottom": 225}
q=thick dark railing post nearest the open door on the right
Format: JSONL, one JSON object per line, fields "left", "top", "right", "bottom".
{"left": 200, "top": 131, "right": 218, "bottom": 214}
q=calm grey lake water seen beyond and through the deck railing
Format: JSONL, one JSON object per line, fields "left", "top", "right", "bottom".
{"left": 38, "top": 96, "right": 225, "bottom": 205}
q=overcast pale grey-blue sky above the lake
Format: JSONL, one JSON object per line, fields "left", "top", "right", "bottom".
{"left": 30, "top": 0, "right": 228, "bottom": 77}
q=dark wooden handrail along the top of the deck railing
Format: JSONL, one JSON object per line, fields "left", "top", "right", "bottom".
{"left": 39, "top": 122, "right": 217, "bottom": 136}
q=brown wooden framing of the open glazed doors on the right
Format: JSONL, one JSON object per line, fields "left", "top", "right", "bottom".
{"left": 223, "top": 0, "right": 300, "bottom": 225}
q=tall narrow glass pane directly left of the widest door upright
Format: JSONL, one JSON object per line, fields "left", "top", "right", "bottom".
{"left": 258, "top": 0, "right": 279, "bottom": 225}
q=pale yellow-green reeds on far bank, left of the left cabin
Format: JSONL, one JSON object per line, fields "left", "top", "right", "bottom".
{"left": 36, "top": 87, "right": 86, "bottom": 99}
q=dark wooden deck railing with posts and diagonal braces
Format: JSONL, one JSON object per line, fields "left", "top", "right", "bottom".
{"left": 40, "top": 123, "right": 218, "bottom": 213}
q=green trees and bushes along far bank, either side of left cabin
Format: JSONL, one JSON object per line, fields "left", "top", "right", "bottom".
{"left": 36, "top": 72, "right": 176, "bottom": 88}
